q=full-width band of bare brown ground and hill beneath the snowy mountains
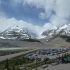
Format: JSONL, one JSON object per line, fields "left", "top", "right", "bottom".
{"left": 0, "top": 37, "right": 70, "bottom": 49}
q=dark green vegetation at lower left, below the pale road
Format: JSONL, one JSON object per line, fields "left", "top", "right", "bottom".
{"left": 0, "top": 54, "right": 34, "bottom": 70}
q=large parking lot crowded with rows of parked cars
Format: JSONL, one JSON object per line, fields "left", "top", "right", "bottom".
{"left": 27, "top": 48, "right": 70, "bottom": 61}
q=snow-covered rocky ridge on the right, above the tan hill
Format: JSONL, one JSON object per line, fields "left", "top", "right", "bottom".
{"left": 42, "top": 24, "right": 70, "bottom": 36}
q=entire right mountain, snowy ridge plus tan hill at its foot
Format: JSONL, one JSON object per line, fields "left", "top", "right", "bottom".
{"left": 41, "top": 24, "right": 70, "bottom": 47}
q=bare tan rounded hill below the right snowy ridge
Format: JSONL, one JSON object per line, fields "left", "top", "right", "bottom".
{"left": 41, "top": 36, "right": 70, "bottom": 48}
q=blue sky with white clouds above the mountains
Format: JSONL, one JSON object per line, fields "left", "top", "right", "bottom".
{"left": 0, "top": 0, "right": 70, "bottom": 37}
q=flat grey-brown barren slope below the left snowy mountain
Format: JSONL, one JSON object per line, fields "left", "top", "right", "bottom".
{"left": 0, "top": 39, "right": 46, "bottom": 49}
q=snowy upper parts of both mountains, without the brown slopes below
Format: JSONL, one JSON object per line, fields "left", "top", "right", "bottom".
{"left": 0, "top": 24, "right": 70, "bottom": 39}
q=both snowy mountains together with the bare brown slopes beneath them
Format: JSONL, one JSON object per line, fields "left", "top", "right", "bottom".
{"left": 0, "top": 24, "right": 70, "bottom": 48}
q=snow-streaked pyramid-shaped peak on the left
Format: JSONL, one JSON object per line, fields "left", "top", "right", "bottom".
{"left": 0, "top": 25, "right": 30, "bottom": 39}
